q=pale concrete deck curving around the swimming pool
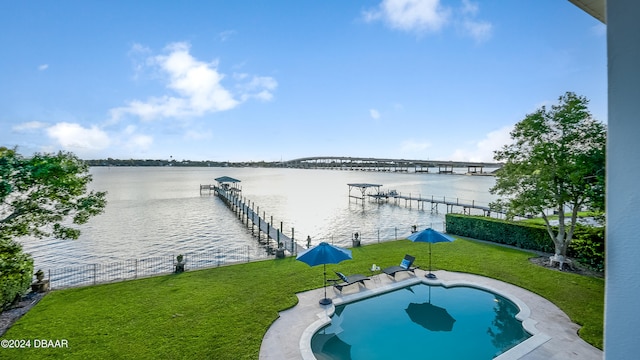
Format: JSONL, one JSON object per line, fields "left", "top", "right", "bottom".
{"left": 260, "top": 270, "right": 603, "bottom": 360}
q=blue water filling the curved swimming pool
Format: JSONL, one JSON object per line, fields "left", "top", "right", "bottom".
{"left": 311, "top": 284, "right": 530, "bottom": 360}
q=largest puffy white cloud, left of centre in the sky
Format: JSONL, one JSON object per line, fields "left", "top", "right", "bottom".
{"left": 111, "top": 42, "right": 278, "bottom": 121}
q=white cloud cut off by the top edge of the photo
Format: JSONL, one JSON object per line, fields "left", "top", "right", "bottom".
{"left": 364, "top": 0, "right": 450, "bottom": 33}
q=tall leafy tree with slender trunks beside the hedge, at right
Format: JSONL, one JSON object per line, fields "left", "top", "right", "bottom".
{"left": 490, "top": 92, "right": 607, "bottom": 256}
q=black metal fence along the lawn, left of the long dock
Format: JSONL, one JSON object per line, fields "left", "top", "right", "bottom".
{"left": 48, "top": 246, "right": 273, "bottom": 289}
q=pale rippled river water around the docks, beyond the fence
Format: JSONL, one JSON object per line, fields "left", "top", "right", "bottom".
{"left": 17, "top": 167, "right": 495, "bottom": 269}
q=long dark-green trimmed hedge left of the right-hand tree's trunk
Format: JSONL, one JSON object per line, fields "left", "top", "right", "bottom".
{"left": 446, "top": 214, "right": 555, "bottom": 253}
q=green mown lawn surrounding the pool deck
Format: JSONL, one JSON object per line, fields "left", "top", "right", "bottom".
{"left": 0, "top": 239, "right": 604, "bottom": 359}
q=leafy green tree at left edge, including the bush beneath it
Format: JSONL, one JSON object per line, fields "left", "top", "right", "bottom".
{"left": 0, "top": 147, "right": 106, "bottom": 306}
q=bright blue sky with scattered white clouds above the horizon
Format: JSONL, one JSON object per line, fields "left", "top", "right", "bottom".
{"left": 0, "top": 0, "right": 607, "bottom": 161}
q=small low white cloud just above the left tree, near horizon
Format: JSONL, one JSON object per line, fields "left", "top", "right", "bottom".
{"left": 47, "top": 122, "right": 111, "bottom": 151}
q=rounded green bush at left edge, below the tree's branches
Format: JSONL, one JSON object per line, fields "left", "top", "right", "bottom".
{"left": 0, "top": 239, "right": 33, "bottom": 310}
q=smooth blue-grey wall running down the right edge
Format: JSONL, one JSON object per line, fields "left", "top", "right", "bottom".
{"left": 604, "top": 0, "right": 640, "bottom": 360}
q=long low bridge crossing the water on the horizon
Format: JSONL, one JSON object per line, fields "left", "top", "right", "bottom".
{"left": 282, "top": 156, "right": 503, "bottom": 175}
